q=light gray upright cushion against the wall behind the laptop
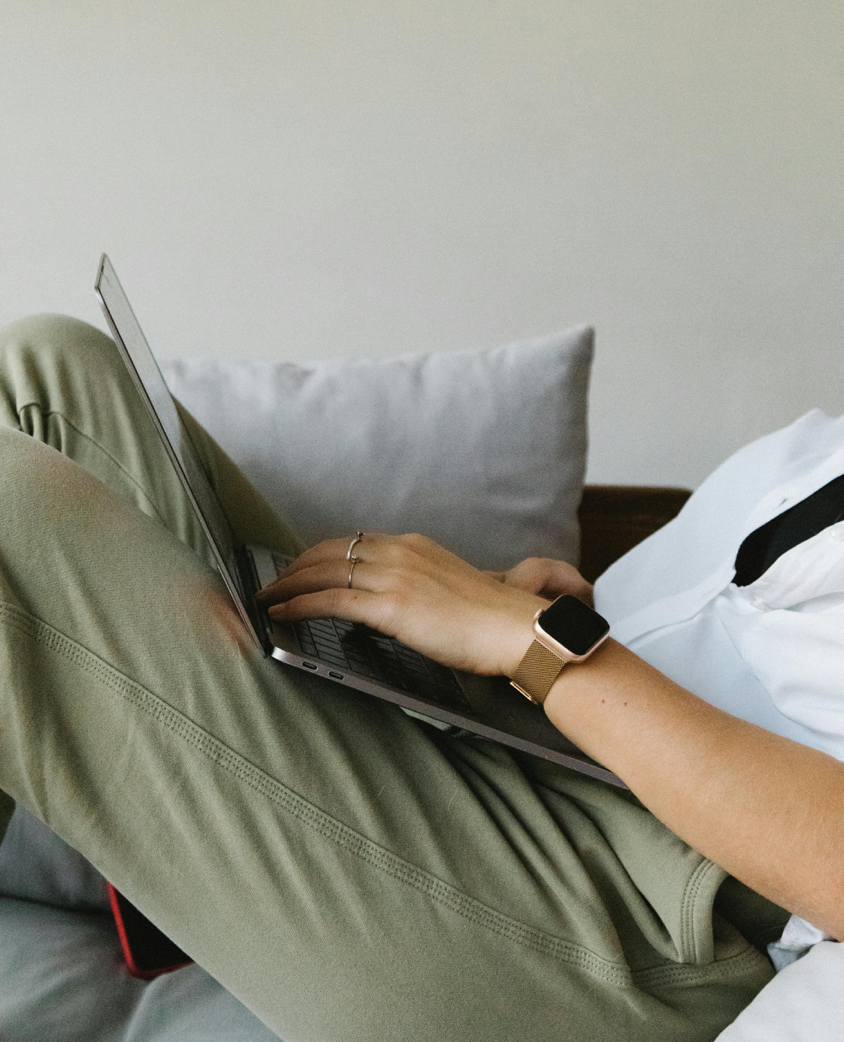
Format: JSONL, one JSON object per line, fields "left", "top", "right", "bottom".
{"left": 163, "top": 326, "right": 593, "bottom": 568}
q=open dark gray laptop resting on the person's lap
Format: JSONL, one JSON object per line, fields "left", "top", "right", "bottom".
{"left": 95, "top": 254, "right": 626, "bottom": 788}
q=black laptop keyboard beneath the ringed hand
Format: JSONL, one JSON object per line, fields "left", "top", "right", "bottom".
{"left": 273, "top": 554, "right": 470, "bottom": 711}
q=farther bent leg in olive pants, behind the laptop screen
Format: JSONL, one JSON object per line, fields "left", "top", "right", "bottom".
{"left": 0, "top": 315, "right": 303, "bottom": 564}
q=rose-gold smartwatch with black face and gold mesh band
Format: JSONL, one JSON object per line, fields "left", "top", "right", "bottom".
{"left": 510, "top": 594, "right": 610, "bottom": 705}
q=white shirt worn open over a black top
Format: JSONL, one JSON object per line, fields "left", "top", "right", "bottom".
{"left": 595, "top": 410, "right": 844, "bottom": 1042}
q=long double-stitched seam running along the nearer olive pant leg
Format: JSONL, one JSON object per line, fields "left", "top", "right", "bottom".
{"left": 0, "top": 602, "right": 755, "bottom": 988}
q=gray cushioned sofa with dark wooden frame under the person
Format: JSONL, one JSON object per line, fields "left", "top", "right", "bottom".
{"left": 0, "top": 326, "right": 821, "bottom": 1042}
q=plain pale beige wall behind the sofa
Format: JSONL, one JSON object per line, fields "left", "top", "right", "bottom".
{"left": 0, "top": 0, "right": 844, "bottom": 485}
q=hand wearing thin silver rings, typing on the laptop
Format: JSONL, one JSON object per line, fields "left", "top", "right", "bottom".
{"left": 257, "top": 532, "right": 546, "bottom": 676}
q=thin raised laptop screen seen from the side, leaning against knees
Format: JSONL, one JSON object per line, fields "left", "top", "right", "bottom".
{"left": 95, "top": 253, "right": 260, "bottom": 643}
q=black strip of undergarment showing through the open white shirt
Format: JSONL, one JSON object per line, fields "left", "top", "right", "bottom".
{"left": 733, "top": 474, "right": 844, "bottom": 586}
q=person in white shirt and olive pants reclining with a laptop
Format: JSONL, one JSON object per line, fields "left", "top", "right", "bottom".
{"left": 0, "top": 317, "right": 844, "bottom": 1042}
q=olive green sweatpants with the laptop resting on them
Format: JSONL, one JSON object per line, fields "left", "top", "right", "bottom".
{"left": 0, "top": 317, "right": 784, "bottom": 1042}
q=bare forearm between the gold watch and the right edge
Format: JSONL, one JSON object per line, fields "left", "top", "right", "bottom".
{"left": 545, "top": 640, "right": 844, "bottom": 937}
